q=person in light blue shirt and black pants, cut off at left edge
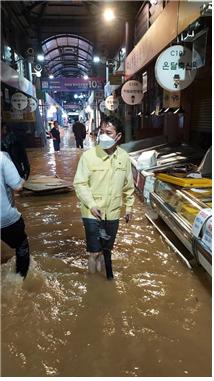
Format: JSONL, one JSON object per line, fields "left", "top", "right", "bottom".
{"left": 0, "top": 152, "right": 30, "bottom": 278}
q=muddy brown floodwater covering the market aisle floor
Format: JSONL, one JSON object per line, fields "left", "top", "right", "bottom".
{"left": 1, "top": 127, "right": 211, "bottom": 377}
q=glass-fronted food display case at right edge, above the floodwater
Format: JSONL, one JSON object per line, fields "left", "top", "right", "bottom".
{"left": 150, "top": 179, "right": 212, "bottom": 275}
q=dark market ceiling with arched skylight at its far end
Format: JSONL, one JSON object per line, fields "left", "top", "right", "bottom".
{"left": 2, "top": 0, "right": 143, "bottom": 77}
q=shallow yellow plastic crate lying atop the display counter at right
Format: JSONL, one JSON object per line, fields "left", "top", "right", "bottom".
{"left": 156, "top": 173, "right": 212, "bottom": 188}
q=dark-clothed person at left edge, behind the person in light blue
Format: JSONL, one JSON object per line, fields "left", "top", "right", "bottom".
{"left": 1, "top": 123, "right": 30, "bottom": 180}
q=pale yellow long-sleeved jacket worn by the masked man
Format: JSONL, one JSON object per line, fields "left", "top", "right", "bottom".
{"left": 74, "top": 146, "right": 134, "bottom": 220}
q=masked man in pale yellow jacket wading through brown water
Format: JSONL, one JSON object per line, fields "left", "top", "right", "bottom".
{"left": 74, "top": 116, "right": 134, "bottom": 280}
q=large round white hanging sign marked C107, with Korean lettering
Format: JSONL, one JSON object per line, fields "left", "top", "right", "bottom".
{"left": 155, "top": 45, "right": 197, "bottom": 91}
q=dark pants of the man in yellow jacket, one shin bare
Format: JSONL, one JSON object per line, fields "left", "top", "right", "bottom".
{"left": 83, "top": 218, "right": 119, "bottom": 279}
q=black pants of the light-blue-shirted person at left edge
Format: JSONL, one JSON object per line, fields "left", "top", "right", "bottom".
{"left": 1, "top": 217, "right": 30, "bottom": 278}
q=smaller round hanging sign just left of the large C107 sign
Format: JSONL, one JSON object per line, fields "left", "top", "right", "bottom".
{"left": 121, "top": 80, "right": 143, "bottom": 105}
